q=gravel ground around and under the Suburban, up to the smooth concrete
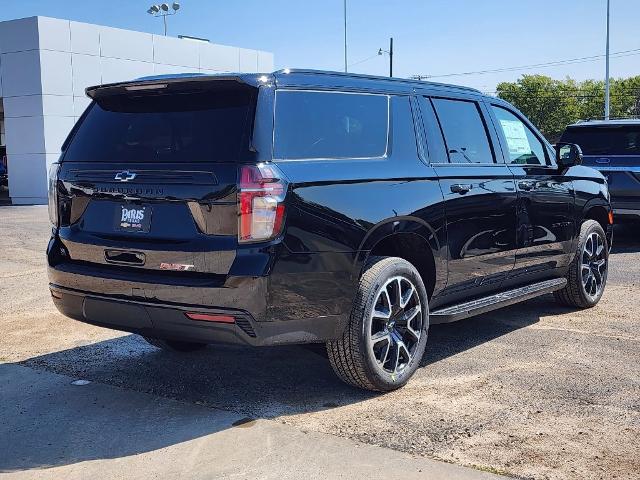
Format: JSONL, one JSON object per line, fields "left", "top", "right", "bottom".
{"left": 0, "top": 207, "right": 640, "bottom": 479}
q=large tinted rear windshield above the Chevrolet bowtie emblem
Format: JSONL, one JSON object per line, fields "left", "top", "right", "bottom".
{"left": 63, "top": 89, "right": 253, "bottom": 162}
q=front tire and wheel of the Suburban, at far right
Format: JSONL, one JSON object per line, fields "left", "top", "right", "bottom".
{"left": 554, "top": 220, "right": 609, "bottom": 308}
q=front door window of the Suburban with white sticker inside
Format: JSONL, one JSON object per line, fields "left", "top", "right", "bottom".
{"left": 491, "top": 105, "right": 546, "bottom": 165}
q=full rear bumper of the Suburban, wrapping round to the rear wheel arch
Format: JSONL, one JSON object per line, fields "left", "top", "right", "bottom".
{"left": 47, "top": 222, "right": 359, "bottom": 345}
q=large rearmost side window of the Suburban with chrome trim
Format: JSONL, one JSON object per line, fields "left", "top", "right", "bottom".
{"left": 274, "top": 90, "right": 389, "bottom": 160}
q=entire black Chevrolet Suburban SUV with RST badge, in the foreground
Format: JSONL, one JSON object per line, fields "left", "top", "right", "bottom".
{"left": 47, "top": 70, "right": 613, "bottom": 391}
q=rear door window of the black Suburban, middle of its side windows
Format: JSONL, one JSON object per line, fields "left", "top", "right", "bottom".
{"left": 432, "top": 98, "right": 494, "bottom": 163}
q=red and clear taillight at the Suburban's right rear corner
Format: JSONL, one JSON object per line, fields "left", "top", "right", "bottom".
{"left": 238, "top": 163, "right": 287, "bottom": 242}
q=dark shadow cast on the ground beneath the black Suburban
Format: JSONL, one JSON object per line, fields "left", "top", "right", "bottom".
{"left": 0, "top": 298, "right": 562, "bottom": 472}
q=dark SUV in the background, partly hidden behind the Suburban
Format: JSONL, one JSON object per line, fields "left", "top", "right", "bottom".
{"left": 561, "top": 119, "right": 640, "bottom": 221}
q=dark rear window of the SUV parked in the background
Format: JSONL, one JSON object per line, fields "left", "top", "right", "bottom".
{"left": 561, "top": 125, "right": 640, "bottom": 155}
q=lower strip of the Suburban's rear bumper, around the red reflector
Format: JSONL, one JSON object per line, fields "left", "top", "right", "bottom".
{"left": 49, "top": 283, "right": 348, "bottom": 346}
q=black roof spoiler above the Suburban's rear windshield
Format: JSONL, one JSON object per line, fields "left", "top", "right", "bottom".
{"left": 85, "top": 73, "right": 273, "bottom": 100}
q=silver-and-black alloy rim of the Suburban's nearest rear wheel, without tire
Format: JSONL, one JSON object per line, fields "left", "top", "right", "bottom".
{"left": 368, "top": 276, "right": 424, "bottom": 375}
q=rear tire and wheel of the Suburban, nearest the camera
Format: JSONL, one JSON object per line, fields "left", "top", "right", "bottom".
{"left": 327, "top": 257, "right": 429, "bottom": 392}
